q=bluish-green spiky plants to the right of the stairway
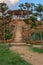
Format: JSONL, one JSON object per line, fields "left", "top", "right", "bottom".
{"left": 25, "top": 32, "right": 43, "bottom": 42}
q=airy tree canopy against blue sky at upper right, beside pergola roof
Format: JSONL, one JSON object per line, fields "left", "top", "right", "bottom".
{"left": 19, "top": 2, "right": 43, "bottom": 22}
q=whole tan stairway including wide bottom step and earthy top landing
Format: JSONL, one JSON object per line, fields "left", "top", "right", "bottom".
{"left": 13, "top": 20, "right": 27, "bottom": 45}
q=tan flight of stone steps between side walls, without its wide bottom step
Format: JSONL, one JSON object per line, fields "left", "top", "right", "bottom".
{"left": 14, "top": 21, "right": 23, "bottom": 43}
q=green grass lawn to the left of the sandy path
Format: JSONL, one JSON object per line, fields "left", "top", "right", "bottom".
{"left": 0, "top": 44, "right": 31, "bottom": 65}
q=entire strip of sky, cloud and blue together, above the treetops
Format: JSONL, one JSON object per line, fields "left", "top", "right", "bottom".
{"left": 0, "top": 0, "right": 43, "bottom": 10}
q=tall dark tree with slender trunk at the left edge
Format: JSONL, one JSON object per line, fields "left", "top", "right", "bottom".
{"left": 0, "top": 3, "right": 12, "bottom": 40}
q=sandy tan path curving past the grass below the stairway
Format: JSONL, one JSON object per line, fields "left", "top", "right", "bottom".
{"left": 10, "top": 46, "right": 43, "bottom": 65}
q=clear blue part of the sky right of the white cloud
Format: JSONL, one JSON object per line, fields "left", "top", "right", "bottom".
{"left": 10, "top": 0, "right": 43, "bottom": 10}
